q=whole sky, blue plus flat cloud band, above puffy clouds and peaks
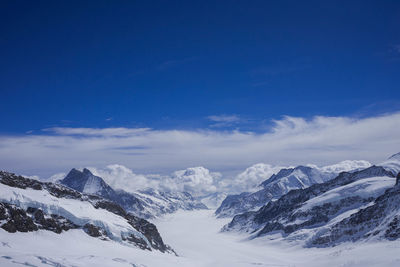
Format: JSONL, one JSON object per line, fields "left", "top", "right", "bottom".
{"left": 0, "top": 1, "right": 400, "bottom": 177}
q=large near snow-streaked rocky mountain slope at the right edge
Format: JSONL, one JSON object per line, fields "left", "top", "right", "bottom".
{"left": 223, "top": 166, "right": 400, "bottom": 249}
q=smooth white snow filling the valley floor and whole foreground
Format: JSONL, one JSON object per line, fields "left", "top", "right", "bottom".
{"left": 0, "top": 210, "right": 400, "bottom": 267}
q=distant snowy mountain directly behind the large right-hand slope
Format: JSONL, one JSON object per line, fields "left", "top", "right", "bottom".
{"left": 215, "top": 161, "right": 370, "bottom": 218}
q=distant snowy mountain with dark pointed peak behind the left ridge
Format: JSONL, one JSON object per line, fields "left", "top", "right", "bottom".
{"left": 60, "top": 168, "right": 207, "bottom": 219}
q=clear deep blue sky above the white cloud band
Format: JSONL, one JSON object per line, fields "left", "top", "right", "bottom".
{"left": 0, "top": 1, "right": 400, "bottom": 133}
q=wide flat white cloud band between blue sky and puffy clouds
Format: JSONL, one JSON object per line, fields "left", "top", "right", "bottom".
{"left": 0, "top": 113, "right": 400, "bottom": 183}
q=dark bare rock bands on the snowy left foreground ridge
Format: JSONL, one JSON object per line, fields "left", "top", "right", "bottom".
{"left": 0, "top": 172, "right": 175, "bottom": 253}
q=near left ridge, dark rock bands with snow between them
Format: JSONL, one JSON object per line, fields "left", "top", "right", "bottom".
{"left": 0, "top": 172, "right": 174, "bottom": 253}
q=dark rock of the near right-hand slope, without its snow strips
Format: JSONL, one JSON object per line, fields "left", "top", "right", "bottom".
{"left": 223, "top": 166, "right": 400, "bottom": 246}
